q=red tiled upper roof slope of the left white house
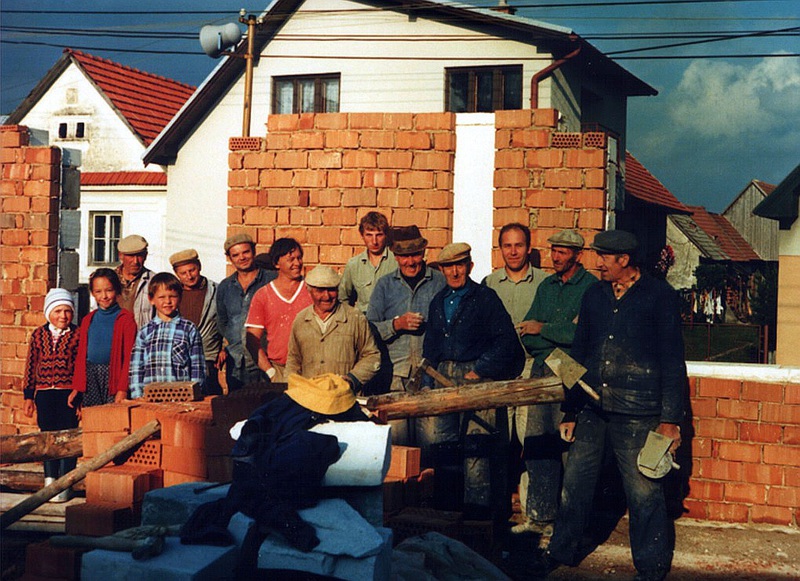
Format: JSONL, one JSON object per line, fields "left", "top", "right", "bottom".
{"left": 64, "top": 48, "right": 195, "bottom": 145}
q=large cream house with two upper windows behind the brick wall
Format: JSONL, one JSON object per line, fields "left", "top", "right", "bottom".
{"left": 143, "top": 0, "right": 656, "bottom": 279}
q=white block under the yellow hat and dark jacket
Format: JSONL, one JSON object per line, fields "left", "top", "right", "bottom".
{"left": 310, "top": 422, "right": 391, "bottom": 486}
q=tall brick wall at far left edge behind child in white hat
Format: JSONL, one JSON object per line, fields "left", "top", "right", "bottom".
{"left": 0, "top": 125, "right": 61, "bottom": 434}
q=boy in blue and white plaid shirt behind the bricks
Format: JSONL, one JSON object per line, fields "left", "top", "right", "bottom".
{"left": 129, "top": 272, "right": 206, "bottom": 399}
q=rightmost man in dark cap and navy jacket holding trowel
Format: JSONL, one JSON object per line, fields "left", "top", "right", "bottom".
{"left": 536, "top": 230, "right": 687, "bottom": 581}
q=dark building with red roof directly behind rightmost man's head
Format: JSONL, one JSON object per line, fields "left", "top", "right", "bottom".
{"left": 616, "top": 151, "right": 691, "bottom": 265}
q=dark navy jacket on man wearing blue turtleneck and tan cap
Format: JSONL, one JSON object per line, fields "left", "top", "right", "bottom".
{"left": 422, "top": 279, "right": 525, "bottom": 380}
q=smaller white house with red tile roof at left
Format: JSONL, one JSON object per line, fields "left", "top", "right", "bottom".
{"left": 6, "top": 49, "right": 194, "bottom": 282}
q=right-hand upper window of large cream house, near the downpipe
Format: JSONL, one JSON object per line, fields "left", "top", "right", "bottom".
{"left": 445, "top": 65, "right": 522, "bottom": 113}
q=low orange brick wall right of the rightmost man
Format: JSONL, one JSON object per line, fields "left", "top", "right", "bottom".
{"left": 684, "top": 377, "right": 800, "bottom": 527}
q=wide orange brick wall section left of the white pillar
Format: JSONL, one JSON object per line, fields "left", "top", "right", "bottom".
{"left": 228, "top": 113, "right": 455, "bottom": 274}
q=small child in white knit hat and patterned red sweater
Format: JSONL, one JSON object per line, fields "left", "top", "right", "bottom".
{"left": 23, "top": 288, "right": 78, "bottom": 502}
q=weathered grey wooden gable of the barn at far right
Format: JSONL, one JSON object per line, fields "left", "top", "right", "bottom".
{"left": 722, "top": 180, "right": 778, "bottom": 261}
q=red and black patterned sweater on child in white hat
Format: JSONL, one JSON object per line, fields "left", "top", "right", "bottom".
{"left": 23, "top": 325, "right": 78, "bottom": 399}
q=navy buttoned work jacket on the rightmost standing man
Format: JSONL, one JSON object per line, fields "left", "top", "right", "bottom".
{"left": 562, "top": 274, "right": 687, "bottom": 423}
